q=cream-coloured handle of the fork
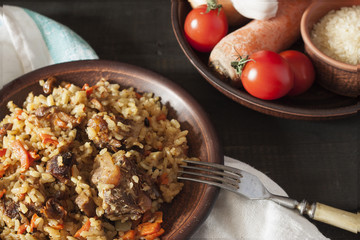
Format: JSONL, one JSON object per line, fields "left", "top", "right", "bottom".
{"left": 313, "top": 203, "right": 360, "bottom": 233}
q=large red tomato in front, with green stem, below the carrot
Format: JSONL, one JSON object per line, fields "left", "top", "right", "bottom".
{"left": 241, "top": 50, "right": 294, "bottom": 100}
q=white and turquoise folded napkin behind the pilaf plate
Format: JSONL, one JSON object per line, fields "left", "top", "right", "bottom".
{"left": 0, "top": 5, "right": 98, "bottom": 89}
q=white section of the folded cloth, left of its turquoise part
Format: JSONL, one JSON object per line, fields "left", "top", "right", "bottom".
{"left": 0, "top": 6, "right": 53, "bottom": 88}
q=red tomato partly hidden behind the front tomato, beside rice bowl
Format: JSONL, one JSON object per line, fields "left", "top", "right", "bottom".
{"left": 280, "top": 50, "right": 315, "bottom": 96}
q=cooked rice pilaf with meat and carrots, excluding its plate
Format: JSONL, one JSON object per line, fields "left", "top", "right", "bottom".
{"left": 0, "top": 78, "right": 197, "bottom": 240}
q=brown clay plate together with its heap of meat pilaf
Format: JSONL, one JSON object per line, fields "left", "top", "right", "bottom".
{"left": 0, "top": 60, "right": 223, "bottom": 240}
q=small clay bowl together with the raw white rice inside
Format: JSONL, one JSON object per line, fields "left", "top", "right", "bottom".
{"left": 301, "top": 0, "right": 360, "bottom": 97}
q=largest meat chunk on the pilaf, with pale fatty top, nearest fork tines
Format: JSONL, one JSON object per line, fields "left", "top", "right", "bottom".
{"left": 92, "top": 151, "right": 153, "bottom": 221}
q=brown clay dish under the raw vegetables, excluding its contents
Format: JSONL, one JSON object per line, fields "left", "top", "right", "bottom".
{"left": 171, "top": 0, "right": 360, "bottom": 120}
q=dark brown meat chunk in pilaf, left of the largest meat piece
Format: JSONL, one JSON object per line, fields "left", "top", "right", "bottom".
{"left": 46, "top": 152, "right": 74, "bottom": 184}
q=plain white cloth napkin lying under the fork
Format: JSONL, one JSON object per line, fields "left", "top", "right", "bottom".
{"left": 191, "top": 157, "right": 327, "bottom": 240}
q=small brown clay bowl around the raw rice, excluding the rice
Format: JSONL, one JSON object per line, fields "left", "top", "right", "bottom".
{"left": 301, "top": 0, "right": 360, "bottom": 97}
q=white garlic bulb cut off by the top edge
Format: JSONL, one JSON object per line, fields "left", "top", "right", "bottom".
{"left": 231, "top": 0, "right": 278, "bottom": 20}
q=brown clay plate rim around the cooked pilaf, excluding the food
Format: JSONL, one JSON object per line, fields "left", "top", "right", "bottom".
{"left": 0, "top": 60, "right": 223, "bottom": 240}
